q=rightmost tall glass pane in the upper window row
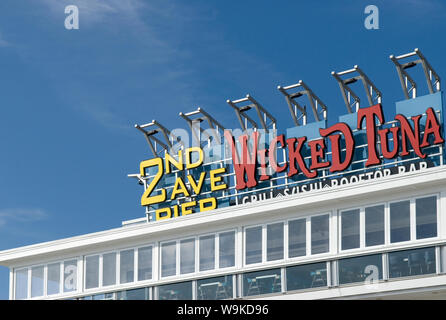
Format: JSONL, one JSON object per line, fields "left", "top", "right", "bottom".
{"left": 415, "top": 196, "right": 437, "bottom": 239}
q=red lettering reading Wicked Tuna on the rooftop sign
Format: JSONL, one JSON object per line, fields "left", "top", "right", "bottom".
{"left": 225, "top": 104, "right": 444, "bottom": 190}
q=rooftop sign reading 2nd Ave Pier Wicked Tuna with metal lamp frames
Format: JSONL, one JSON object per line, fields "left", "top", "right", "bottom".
{"left": 131, "top": 51, "right": 444, "bottom": 220}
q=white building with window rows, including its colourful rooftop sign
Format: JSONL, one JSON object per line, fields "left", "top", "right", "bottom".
{"left": 0, "top": 50, "right": 446, "bottom": 300}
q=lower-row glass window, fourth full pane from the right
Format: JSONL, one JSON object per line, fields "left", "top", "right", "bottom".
{"left": 243, "top": 269, "right": 282, "bottom": 296}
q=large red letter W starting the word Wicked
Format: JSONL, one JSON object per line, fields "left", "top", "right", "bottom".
{"left": 225, "top": 130, "right": 259, "bottom": 190}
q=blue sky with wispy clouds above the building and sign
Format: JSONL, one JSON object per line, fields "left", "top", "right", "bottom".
{"left": 0, "top": 0, "right": 446, "bottom": 299}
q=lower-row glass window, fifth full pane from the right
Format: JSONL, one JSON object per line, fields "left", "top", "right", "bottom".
{"left": 197, "top": 275, "right": 233, "bottom": 300}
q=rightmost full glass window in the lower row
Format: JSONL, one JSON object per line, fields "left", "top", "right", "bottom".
{"left": 389, "top": 248, "right": 436, "bottom": 278}
